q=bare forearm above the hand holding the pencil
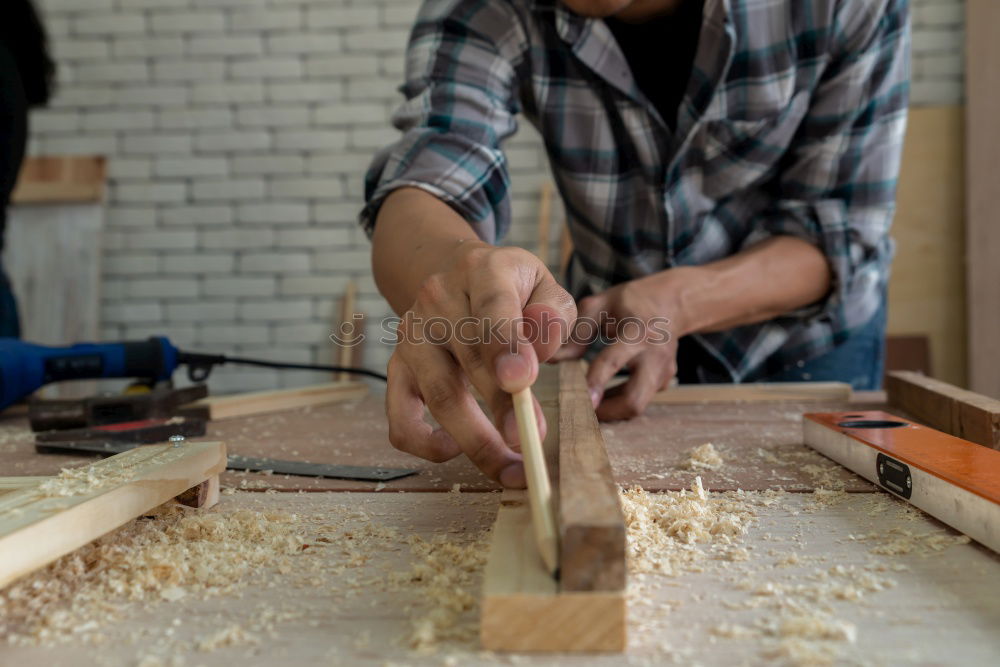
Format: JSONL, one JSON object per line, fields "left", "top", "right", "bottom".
{"left": 372, "top": 188, "right": 479, "bottom": 314}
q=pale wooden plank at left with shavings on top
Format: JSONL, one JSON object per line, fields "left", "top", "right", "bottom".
{"left": 0, "top": 442, "right": 226, "bottom": 588}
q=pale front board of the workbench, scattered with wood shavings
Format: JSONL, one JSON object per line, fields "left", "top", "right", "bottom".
{"left": 0, "top": 492, "right": 1000, "bottom": 667}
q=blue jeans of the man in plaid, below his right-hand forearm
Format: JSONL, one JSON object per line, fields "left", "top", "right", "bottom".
{"left": 764, "top": 300, "right": 886, "bottom": 390}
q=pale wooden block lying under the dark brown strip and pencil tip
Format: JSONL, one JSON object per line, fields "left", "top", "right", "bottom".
{"left": 480, "top": 490, "right": 626, "bottom": 652}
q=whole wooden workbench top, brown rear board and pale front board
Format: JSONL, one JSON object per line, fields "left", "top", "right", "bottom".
{"left": 0, "top": 388, "right": 1000, "bottom": 667}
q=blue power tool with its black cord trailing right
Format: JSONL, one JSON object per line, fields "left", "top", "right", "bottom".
{"left": 0, "top": 336, "right": 386, "bottom": 410}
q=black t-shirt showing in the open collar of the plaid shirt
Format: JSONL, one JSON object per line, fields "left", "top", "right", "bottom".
{"left": 605, "top": 0, "right": 704, "bottom": 129}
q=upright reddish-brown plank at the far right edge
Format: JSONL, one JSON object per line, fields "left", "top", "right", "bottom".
{"left": 965, "top": 0, "right": 1000, "bottom": 398}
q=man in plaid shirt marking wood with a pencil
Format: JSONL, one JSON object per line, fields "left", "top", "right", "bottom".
{"left": 361, "top": 0, "right": 909, "bottom": 486}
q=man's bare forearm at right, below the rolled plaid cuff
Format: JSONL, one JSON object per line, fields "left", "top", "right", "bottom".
{"left": 662, "top": 236, "right": 832, "bottom": 336}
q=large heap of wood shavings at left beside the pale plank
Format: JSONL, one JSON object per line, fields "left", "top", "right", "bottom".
{"left": 0, "top": 505, "right": 304, "bottom": 644}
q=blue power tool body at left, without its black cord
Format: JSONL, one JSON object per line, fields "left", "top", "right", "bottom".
{"left": 0, "top": 336, "right": 177, "bottom": 410}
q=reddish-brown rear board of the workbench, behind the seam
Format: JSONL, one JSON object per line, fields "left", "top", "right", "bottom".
{"left": 0, "top": 394, "right": 884, "bottom": 491}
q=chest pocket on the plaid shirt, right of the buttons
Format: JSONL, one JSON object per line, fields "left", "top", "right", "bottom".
{"left": 690, "top": 92, "right": 809, "bottom": 201}
